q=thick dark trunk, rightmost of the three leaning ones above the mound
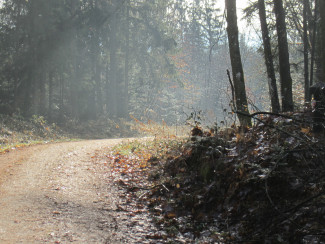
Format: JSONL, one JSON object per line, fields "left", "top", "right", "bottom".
{"left": 274, "top": 0, "right": 293, "bottom": 112}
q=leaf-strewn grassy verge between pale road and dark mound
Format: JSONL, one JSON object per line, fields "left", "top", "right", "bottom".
{"left": 101, "top": 139, "right": 189, "bottom": 243}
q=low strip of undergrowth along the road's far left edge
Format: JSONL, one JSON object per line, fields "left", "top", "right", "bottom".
{"left": 0, "top": 114, "right": 185, "bottom": 153}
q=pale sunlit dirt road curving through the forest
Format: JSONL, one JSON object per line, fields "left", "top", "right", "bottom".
{"left": 0, "top": 139, "right": 154, "bottom": 244}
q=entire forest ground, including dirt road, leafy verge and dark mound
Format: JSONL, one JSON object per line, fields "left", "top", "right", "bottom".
{"left": 0, "top": 113, "right": 325, "bottom": 243}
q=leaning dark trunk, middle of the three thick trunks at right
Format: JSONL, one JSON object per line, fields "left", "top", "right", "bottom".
{"left": 258, "top": 0, "right": 280, "bottom": 113}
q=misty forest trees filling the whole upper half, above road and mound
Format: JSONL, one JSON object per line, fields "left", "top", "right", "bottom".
{"left": 0, "top": 0, "right": 325, "bottom": 126}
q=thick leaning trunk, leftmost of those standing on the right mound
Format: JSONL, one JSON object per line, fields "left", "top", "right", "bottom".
{"left": 225, "top": 0, "right": 251, "bottom": 126}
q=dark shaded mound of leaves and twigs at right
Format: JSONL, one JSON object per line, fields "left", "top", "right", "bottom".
{"left": 146, "top": 114, "right": 325, "bottom": 243}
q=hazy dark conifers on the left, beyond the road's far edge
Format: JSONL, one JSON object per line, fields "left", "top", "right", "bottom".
{"left": 0, "top": 0, "right": 180, "bottom": 121}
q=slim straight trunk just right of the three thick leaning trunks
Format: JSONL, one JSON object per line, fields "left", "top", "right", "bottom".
{"left": 303, "top": 0, "right": 310, "bottom": 103}
